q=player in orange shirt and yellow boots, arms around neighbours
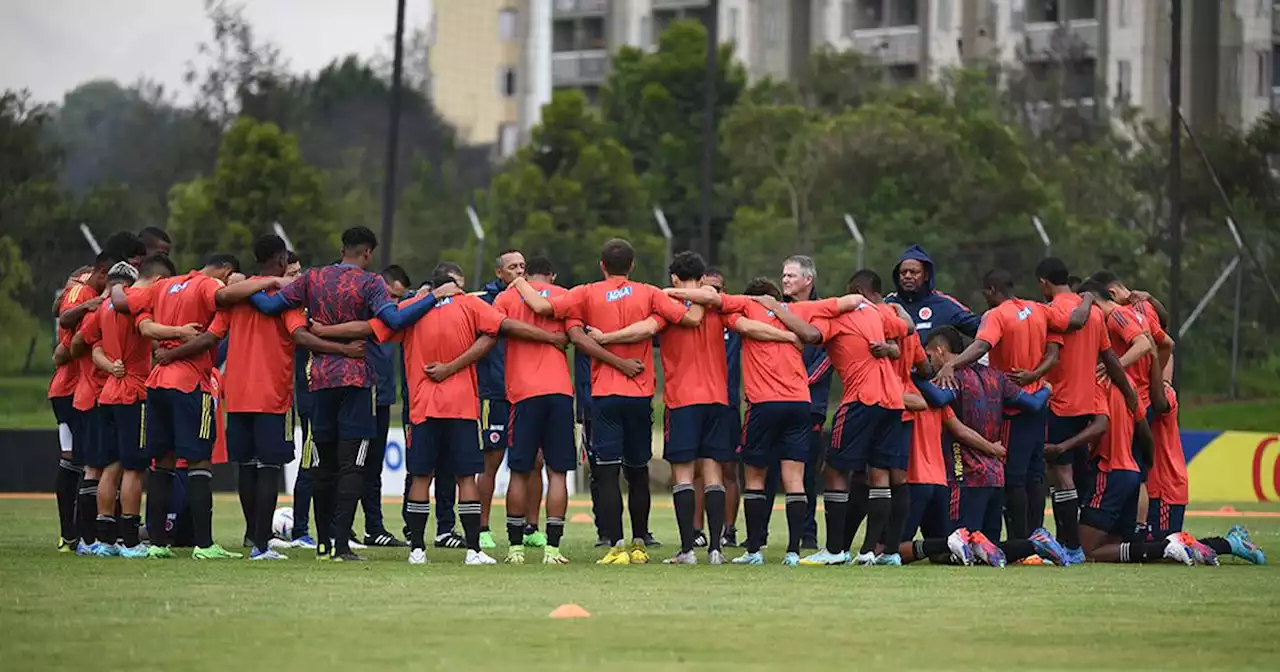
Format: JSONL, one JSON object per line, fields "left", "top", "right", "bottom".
{"left": 512, "top": 238, "right": 701, "bottom": 564}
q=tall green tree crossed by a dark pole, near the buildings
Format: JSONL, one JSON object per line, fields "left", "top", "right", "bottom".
{"left": 600, "top": 20, "right": 746, "bottom": 257}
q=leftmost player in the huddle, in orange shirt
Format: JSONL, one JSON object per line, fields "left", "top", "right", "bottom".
{"left": 49, "top": 252, "right": 111, "bottom": 553}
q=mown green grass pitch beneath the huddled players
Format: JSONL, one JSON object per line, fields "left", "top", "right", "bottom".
{"left": 0, "top": 495, "right": 1280, "bottom": 671}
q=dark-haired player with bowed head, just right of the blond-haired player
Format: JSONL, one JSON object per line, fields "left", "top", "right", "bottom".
{"left": 92, "top": 255, "right": 177, "bottom": 558}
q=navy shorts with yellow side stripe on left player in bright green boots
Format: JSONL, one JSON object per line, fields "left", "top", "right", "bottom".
{"left": 145, "top": 388, "right": 218, "bottom": 462}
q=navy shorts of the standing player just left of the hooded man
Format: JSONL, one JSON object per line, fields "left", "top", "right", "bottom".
{"left": 827, "top": 402, "right": 911, "bottom": 472}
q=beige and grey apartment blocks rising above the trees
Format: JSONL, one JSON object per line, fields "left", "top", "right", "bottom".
{"left": 430, "top": 0, "right": 1280, "bottom": 156}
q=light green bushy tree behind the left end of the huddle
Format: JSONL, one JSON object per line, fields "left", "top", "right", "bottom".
{"left": 169, "top": 118, "right": 337, "bottom": 265}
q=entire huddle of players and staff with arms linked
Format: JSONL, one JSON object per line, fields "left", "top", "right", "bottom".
{"left": 49, "top": 227, "right": 1266, "bottom": 567}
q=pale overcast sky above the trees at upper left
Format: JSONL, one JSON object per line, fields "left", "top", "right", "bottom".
{"left": 0, "top": 0, "right": 432, "bottom": 102}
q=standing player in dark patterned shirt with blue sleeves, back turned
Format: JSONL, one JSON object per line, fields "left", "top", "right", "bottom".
{"left": 252, "top": 227, "right": 450, "bottom": 562}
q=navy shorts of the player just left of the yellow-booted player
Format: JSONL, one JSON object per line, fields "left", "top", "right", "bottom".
{"left": 507, "top": 394, "right": 577, "bottom": 474}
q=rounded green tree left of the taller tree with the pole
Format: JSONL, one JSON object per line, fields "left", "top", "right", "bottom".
{"left": 481, "top": 91, "right": 664, "bottom": 284}
